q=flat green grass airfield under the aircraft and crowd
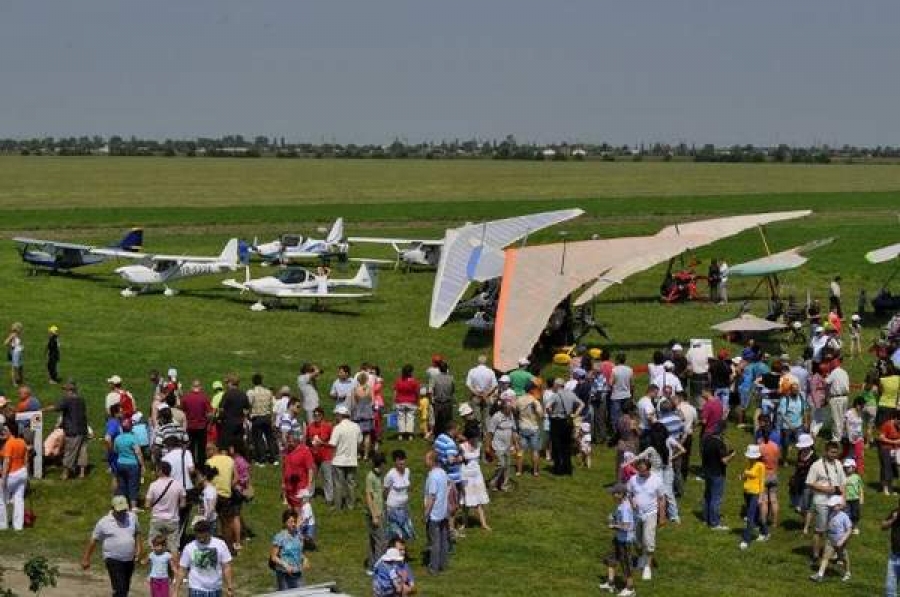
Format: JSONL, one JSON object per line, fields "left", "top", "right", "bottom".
{"left": 0, "top": 158, "right": 900, "bottom": 596}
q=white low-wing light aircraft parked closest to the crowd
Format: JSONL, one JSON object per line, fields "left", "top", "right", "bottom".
{"left": 222, "top": 263, "right": 376, "bottom": 311}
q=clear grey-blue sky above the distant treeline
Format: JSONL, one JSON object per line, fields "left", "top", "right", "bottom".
{"left": 0, "top": 0, "right": 900, "bottom": 145}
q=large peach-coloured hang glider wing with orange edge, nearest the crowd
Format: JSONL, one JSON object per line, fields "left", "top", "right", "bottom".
{"left": 494, "top": 211, "right": 809, "bottom": 370}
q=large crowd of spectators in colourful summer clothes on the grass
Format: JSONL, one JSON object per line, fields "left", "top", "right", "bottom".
{"left": 0, "top": 305, "right": 900, "bottom": 597}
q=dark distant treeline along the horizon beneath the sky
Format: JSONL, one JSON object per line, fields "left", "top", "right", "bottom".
{"left": 0, "top": 135, "right": 900, "bottom": 164}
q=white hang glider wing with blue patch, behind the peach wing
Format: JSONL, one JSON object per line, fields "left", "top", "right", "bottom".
{"left": 429, "top": 209, "right": 584, "bottom": 328}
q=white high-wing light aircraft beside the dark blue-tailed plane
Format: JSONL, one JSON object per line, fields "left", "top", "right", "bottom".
{"left": 91, "top": 238, "right": 239, "bottom": 297}
